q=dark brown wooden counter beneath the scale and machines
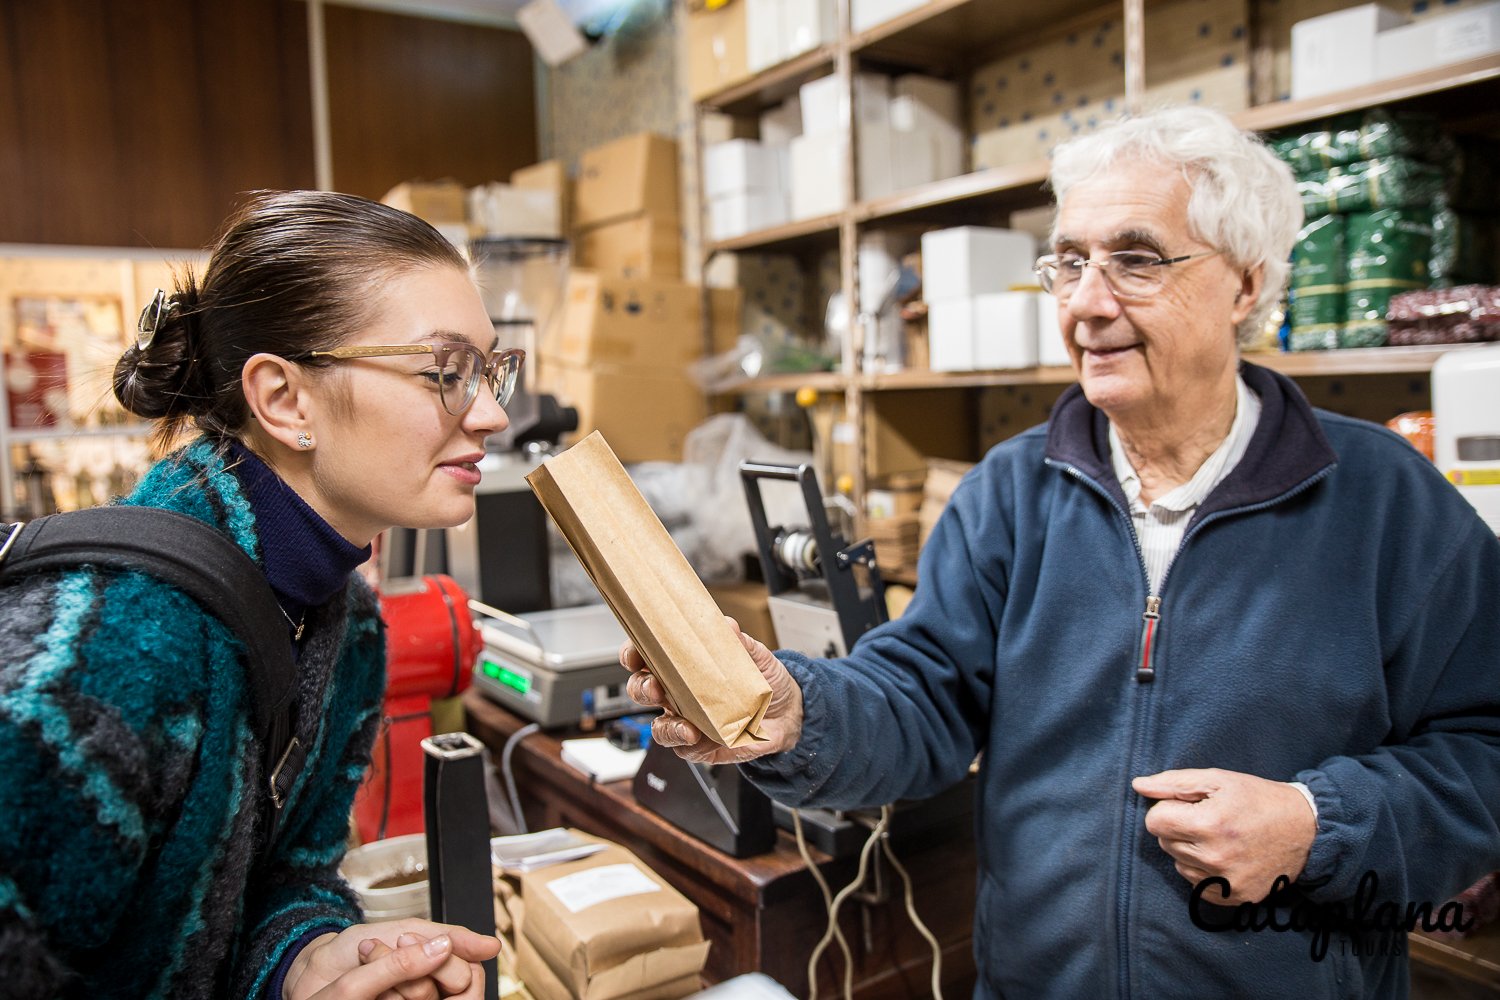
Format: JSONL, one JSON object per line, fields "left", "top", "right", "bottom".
{"left": 464, "top": 688, "right": 975, "bottom": 999}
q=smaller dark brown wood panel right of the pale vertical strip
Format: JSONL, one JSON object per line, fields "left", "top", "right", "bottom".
{"left": 324, "top": 4, "right": 537, "bottom": 198}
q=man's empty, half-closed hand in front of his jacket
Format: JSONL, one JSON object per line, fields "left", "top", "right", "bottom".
{"left": 1131, "top": 768, "right": 1317, "bottom": 904}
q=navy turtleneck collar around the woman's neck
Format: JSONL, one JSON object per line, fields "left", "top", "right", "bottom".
{"left": 230, "top": 441, "right": 371, "bottom": 622}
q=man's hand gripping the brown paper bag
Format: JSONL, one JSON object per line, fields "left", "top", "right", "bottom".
{"left": 620, "top": 616, "right": 803, "bottom": 765}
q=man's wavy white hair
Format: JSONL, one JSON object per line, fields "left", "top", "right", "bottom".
{"left": 1050, "top": 106, "right": 1302, "bottom": 346}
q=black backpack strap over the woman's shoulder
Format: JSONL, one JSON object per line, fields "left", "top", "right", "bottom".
{"left": 0, "top": 507, "right": 308, "bottom": 850}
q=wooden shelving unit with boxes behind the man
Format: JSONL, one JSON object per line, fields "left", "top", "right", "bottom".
{"left": 687, "top": 0, "right": 1500, "bottom": 512}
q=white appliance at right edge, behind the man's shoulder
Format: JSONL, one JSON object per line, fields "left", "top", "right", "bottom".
{"left": 1433, "top": 343, "right": 1500, "bottom": 535}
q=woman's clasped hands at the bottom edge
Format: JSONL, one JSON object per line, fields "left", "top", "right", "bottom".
{"left": 282, "top": 919, "right": 500, "bottom": 1000}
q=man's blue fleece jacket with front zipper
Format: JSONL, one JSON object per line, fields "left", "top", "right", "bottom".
{"left": 744, "top": 364, "right": 1500, "bottom": 1000}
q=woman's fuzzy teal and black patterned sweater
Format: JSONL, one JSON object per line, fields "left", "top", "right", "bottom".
{"left": 0, "top": 439, "right": 386, "bottom": 999}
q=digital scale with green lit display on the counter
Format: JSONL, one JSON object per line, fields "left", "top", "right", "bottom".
{"left": 470, "top": 601, "right": 641, "bottom": 729}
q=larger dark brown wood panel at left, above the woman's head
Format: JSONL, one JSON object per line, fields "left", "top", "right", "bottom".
{"left": 0, "top": 0, "right": 314, "bottom": 247}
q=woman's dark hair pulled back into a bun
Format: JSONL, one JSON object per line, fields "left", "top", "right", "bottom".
{"left": 114, "top": 190, "right": 468, "bottom": 444}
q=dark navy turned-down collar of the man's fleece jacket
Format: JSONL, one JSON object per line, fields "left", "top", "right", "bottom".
{"left": 1047, "top": 361, "right": 1338, "bottom": 520}
